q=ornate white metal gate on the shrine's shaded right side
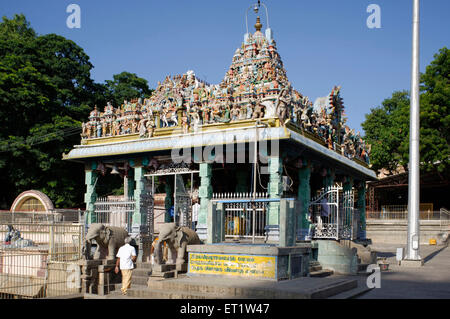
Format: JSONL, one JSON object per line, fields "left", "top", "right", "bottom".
{"left": 309, "top": 186, "right": 356, "bottom": 240}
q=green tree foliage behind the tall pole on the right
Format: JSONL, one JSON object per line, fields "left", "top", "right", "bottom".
{"left": 362, "top": 47, "right": 450, "bottom": 173}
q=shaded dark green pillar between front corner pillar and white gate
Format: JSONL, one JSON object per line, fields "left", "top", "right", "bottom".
{"left": 297, "top": 160, "right": 311, "bottom": 240}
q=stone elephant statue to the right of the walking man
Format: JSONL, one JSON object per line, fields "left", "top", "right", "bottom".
{"left": 154, "top": 223, "right": 202, "bottom": 265}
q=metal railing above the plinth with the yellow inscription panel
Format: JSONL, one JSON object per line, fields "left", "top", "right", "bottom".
{"left": 212, "top": 193, "right": 269, "bottom": 239}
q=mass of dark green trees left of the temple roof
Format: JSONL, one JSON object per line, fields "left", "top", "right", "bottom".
{"left": 0, "top": 15, "right": 150, "bottom": 209}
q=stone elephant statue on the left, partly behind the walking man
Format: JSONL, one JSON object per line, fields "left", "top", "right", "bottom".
{"left": 84, "top": 223, "right": 129, "bottom": 260}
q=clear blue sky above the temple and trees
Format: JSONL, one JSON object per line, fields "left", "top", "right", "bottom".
{"left": 0, "top": 0, "right": 450, "bottom": 134}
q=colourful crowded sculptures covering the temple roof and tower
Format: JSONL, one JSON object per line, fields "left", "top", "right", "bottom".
{"left": 81, "top": 17, "right": 370, "bottom": 163}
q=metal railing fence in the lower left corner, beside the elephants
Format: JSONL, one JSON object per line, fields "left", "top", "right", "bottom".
{"left": 0, "top": 221, "right": 84, "bottom": 299}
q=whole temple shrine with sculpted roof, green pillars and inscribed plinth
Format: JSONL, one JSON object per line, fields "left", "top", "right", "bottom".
{"left": 63, "top": 4, "right": 376, "bottom": 280}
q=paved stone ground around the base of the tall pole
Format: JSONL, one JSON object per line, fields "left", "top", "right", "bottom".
{"left": 358, "top": 244, "right": 450, "bottom": 299}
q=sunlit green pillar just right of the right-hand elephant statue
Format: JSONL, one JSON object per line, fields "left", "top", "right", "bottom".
{"left": 197, "top": 163, "right": 213, "bottom": 241}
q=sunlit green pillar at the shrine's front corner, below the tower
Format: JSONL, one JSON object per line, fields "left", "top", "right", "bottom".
{"left": 267, "top": 157, "right": 283, "bottom": 225}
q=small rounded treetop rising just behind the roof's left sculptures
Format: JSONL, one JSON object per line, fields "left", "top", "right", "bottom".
{"left": 105, "top": 72, "right": 152, "bottom": 107}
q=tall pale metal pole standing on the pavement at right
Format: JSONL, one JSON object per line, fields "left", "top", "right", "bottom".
{"left": 406, "top": 0, "right": 421, "bottom": 260}
